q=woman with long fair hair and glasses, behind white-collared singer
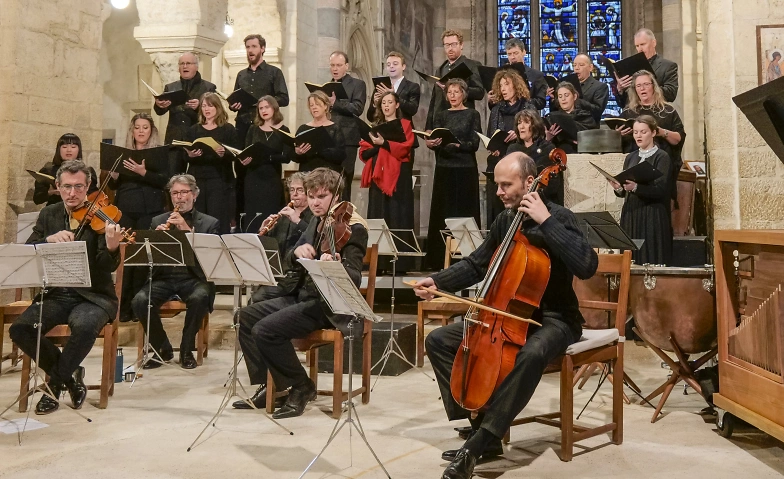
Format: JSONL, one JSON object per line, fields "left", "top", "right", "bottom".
{"left": 619, "top": 70, "right": 686, "bottom": 199}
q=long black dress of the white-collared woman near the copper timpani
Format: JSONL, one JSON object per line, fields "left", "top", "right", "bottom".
{"left": 616, "top": 149, "right": 672, "bottom": 265}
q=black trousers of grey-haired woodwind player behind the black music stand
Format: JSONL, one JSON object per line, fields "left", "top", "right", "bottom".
{"left": 132, "top": 276, "right": 212, "bottom": 354}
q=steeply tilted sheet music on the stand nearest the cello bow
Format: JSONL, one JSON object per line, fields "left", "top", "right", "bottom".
{"left": 297, "top": 259, "right": 382, "bottom": 322}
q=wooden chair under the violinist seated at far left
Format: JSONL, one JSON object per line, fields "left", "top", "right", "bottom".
{"left": 14, "top": 244, "right": 125, "bottom": 412}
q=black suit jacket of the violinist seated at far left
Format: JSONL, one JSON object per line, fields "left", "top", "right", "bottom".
{"left": 27, "top": 202, "right": 120, "bottom": 319}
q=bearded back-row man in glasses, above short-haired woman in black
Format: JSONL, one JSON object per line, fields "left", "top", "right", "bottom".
{"left": 425, "top": 30, "right": 485, "bottom": 130}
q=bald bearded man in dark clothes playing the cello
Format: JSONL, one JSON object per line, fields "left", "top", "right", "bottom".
{"left": 414, "top": 152, "right": 599, "bottom": 479}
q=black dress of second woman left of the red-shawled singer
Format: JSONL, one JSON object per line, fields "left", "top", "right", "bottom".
{"left": 243, "top": 125, "right": 294, "bottom": 229}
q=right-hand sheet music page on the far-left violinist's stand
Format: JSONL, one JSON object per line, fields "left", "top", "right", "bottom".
{"left": 35, "top": 241, "right": 92, "bottom": 288}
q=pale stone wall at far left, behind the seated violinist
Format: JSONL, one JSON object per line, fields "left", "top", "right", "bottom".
{"left": 0, "top": 0, "right": 107, "bottom": 242}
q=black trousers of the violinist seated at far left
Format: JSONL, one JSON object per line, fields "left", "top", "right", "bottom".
{"left": 8, "top": 288, "right": 111, "bottom": 383}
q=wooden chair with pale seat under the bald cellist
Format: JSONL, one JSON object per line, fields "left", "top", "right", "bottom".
{"left": 504, "top": 251, "right": 632, "bottom": 461}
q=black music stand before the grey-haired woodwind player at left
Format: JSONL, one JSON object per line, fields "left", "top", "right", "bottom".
{"left": 125, "top": 229, "right": 195, "bottom": 387}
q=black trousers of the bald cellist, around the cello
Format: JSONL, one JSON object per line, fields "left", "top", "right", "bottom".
{"left": 425, "top": 318, "right": 579, "bottom": 437}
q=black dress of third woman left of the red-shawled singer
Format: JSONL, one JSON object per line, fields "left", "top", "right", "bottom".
{"left": 187, "top": 123, "right": 241, "bottom": 234}
